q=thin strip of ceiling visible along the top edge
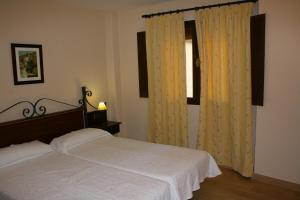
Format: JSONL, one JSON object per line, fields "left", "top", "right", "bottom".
{"left": 63, "top": 0, "right": 176, "bottom": 10}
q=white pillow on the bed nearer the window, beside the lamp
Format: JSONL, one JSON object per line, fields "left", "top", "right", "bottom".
{"left": 50, "top": 128, "right": 111, "bottom": 154}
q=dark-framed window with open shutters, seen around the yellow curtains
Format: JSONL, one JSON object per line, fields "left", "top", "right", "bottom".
{"left": 137, "top": 14, "right": 265, "bottom": 105}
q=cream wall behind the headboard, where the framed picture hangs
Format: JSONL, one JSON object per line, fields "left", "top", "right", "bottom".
{"left": 0, "top": 0, "right": 107, "bottom": 121}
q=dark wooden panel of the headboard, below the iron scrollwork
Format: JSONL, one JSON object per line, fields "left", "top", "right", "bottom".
{"left": 0, "top": 108, "right": 84, "bottom": 148}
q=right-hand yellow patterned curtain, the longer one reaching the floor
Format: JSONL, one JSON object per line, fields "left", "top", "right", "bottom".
{"left": 196, "top": 3, "right": 253, "bottom": 177}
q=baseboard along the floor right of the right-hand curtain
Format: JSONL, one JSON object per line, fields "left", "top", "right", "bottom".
{"left": 252, "top": 174, "right": 300, "bottom": 192}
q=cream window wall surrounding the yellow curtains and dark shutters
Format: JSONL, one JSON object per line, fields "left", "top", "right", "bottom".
{"left": 113, "top": 0, "right": 300, "bottom": 183}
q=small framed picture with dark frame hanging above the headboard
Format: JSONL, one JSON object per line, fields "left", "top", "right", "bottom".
{"left": 11, "top": 43, "right": 44, "bottom": 85}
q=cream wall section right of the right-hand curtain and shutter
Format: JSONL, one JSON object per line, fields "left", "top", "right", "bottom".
{"left": 255, "top": 0, "right": 300, "bottom": 183}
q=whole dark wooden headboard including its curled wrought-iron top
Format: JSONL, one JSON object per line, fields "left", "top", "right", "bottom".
{"left": 0, "top": 87, "right": 97, "bottom": 148}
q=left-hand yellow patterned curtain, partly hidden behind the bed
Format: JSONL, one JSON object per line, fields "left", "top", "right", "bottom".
{"left": 146, "top": 14, "right": 187, "bottom": 146}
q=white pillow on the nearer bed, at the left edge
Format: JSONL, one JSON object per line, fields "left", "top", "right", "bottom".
{"left": 0, "top": 140, "right": 53, "bottom": 168}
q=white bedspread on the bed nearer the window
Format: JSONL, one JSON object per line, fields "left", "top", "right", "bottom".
{"left": 67, "top": 135, "right": 221, "bottom": 200}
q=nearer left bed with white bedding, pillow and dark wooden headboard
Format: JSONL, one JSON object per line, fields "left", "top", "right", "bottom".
{"left": 0, "top": 108, "right": 171, "bottom": 200}
